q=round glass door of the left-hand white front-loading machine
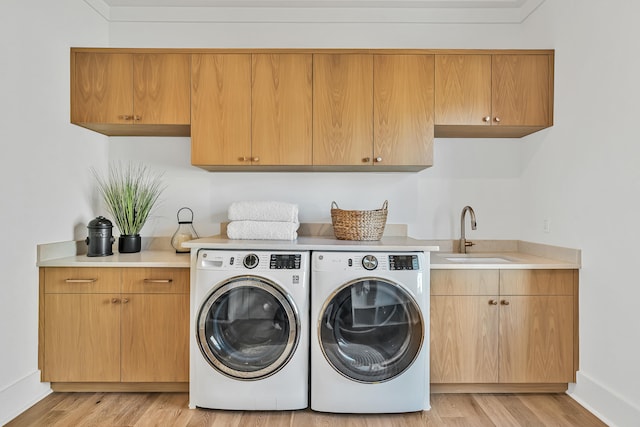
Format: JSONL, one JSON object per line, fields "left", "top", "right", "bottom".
{"left": 196, "top": 276, "right": 300, "bottom": 380}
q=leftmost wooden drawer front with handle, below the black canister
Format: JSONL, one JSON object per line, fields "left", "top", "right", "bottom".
{"left": 44, "top": 267, "right": 120, "bottom": 294}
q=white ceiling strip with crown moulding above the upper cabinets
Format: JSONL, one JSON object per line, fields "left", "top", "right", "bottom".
{"left": 84, "top": 0, "right": 544, "bottom": 23}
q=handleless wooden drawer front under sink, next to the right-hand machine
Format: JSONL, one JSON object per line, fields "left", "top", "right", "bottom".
{"left": 431, "top": 270, "right": 500, "bottom": 295}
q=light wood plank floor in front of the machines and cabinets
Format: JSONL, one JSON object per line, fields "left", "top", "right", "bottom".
{"left": 7, "top": 393, "right": 605, "bottom": 427}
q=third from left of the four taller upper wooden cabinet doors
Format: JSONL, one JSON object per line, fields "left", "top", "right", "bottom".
{"left": 313, "top": 54, "right": 373, "bottom": 166}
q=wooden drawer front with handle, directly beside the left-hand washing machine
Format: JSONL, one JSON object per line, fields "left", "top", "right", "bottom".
{"left": 122, "top": 267, "right": 189, "bottom": 294}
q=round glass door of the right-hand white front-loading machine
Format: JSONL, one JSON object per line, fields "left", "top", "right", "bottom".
{"left": 318, "top": 278, "right": 425, "bottom": 383}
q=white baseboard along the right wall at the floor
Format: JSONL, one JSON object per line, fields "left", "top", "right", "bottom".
{"left": 567, "top": 371, "right": 640, "bottom": 427}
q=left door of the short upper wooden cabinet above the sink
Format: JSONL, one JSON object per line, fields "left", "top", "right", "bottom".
{"left": 435, "top": 55, "right": 491, "bottom": 126}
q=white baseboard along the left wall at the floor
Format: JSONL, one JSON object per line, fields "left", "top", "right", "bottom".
{"left": 0, "top": 371, "right": 51, "bottom": 425}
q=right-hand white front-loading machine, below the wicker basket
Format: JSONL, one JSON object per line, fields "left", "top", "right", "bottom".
{"left": 310, "top": 252, "right": 430, "bottom": 413}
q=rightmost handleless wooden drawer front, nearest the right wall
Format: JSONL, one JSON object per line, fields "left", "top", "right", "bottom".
{"left": 500, "top": 270, "right": 578, "bottom": 295}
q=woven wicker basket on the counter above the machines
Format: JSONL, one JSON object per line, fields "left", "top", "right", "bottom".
{"left": 331, "top": 200, "right": 389, "bottom": 240}
